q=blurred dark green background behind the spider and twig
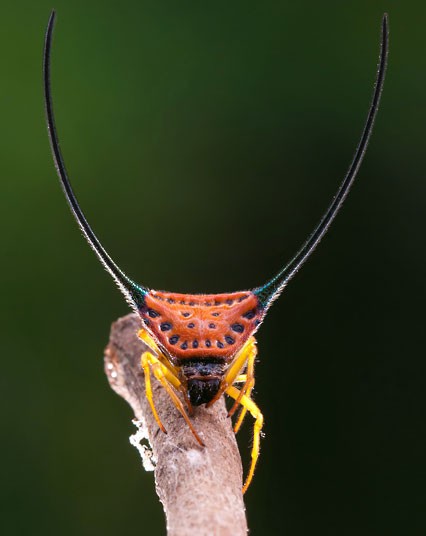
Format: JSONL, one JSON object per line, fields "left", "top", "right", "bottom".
{"left": 0, "top": 0, "right": 426, "bottom": 536}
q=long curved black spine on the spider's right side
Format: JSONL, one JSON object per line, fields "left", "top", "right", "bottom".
{"left": 253, "top": 13, "right": 389, "bottom": 308}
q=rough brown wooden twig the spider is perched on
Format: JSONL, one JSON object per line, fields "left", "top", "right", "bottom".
{"left": 105, "top": 314, "right": 247, "bottom": 536}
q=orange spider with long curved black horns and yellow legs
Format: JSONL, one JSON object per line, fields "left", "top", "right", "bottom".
{"left": 43, "top": 11, "right": 388, "bottom": 492}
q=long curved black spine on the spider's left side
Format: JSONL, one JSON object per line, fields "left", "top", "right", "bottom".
{"left": 43, "top": 11, "right": 148, "bottom": 309}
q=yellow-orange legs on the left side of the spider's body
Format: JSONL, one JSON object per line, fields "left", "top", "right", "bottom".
{"left": 138, "top": 329, "right": 205, "bottom": 447}
